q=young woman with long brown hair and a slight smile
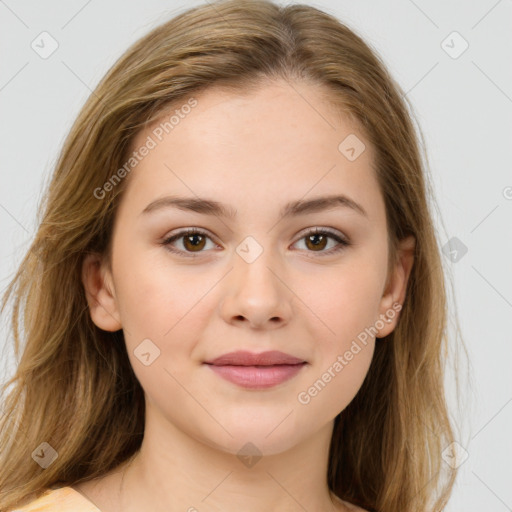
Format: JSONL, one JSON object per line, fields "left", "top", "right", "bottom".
{"left": 0, "top": 0, "right": 464, "bottom": 512}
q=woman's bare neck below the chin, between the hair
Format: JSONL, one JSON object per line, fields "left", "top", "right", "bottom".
{"left": 120, "top": 406, "right": 343, "bottom": 512}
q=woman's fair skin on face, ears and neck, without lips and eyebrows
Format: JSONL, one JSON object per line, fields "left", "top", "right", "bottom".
{"left": 75, "top": 81, "right": 413, "bottom": 512}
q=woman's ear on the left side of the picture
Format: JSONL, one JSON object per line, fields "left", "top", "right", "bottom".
{"left": 82, "top": 253, "right": 122, "bottom": 331}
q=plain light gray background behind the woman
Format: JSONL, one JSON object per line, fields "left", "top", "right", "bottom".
{"left": 0, "top": 0, "right": 512, "bottom": 512}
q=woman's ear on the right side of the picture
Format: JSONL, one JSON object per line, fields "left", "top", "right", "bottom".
{"left": 376, "top": 235, "right": 416, "bottom": 338}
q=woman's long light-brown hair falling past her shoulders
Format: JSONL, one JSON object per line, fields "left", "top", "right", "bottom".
{"left": 0, "top": 0, "right": 468, "bottom": 512}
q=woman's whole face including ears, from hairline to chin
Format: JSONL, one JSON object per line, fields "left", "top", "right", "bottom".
{"left": 83, "top": 82, "right": 412, "bottom": 454}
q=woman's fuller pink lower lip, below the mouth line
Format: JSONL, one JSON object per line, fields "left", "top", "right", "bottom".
{"left": 208, "top": 363, "right": 306, "bottom": 389}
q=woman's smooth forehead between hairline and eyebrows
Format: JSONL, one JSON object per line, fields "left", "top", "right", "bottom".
{"left": 121, "top": 81, "right": 383, "bottom": 222}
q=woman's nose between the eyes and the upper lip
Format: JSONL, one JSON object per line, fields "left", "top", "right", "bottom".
{"left": 221, "top": 251, "right": 293, "bottom": 329}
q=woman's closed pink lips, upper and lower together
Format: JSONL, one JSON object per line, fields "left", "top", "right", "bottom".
{"left": 204, "top": 350, "right": 307, "bottom": 389}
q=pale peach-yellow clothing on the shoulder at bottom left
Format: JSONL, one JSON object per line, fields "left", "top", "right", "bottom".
{"left": 11, "top": 487, "right": 99, "bottom": 512}
